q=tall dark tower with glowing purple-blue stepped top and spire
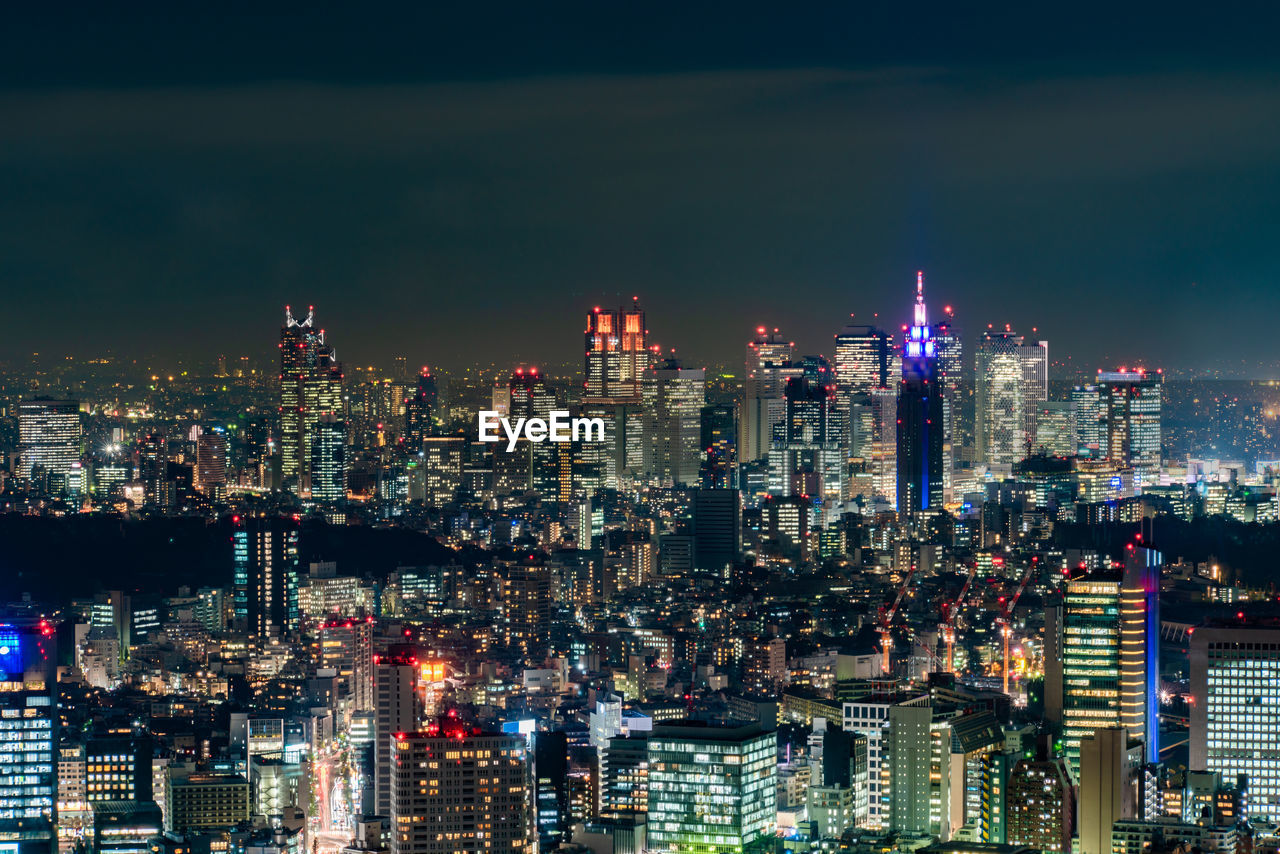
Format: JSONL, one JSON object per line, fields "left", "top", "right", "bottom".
{"left": 897, "top": 273, "right": 945, "bottom": 519}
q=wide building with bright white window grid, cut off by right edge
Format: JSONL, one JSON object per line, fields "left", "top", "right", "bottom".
{"left": 1188, "top": 620, "right": 1280, "bottom": 822}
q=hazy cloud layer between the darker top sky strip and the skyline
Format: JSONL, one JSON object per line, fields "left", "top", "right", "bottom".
{"left": 0, "top": 64, "right": 1280, "bottom": 366}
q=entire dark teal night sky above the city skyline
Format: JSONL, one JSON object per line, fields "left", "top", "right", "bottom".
{"left": 0, "top": 1, "right": 1280, "bottom": 374}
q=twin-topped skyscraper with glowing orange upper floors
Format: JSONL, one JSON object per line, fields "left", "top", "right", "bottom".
{"left": 582, "top": 297, "right": 650, "bottom": 403}
